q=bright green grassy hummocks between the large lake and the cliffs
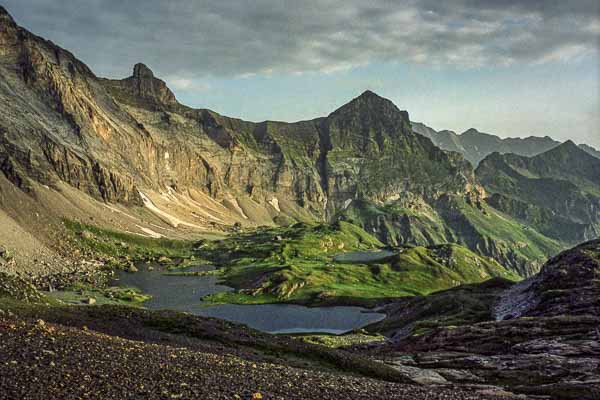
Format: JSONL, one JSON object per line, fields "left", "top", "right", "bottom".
{"left": 198, "top": 221, "right": 519, "bottom": 306}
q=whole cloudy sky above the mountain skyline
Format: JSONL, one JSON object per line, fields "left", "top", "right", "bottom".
{"left": 0, "top": 0, "right": 600, "bottom": 148}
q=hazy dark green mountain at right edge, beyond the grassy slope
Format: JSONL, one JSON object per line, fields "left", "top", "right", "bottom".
{"left": 476, "top": 141, "right": 600, "bottom": 243}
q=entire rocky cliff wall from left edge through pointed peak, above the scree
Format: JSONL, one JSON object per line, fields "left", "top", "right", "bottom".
{"left": 0, "top": 7, "right": 474, "bottom": 223}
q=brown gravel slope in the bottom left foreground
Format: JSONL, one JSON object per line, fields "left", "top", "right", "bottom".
{"left": 0, "top": 315, "right": 516, "bottom": 400}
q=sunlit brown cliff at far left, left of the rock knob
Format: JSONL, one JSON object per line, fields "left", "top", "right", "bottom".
{"left": 0, "top": 7, "right": 150, "bottom": 202}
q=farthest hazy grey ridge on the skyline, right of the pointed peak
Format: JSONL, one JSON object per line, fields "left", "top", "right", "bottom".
{"left": 412, "top": 122, "right": 600, "bottom": 167}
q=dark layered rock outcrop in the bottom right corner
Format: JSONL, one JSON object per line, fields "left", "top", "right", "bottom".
{"left": 361, "top": 241, "right": 600, "bottom": 400}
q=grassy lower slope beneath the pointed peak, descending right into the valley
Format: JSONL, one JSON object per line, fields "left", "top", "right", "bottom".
{"left": 337, "top": 195, "right": 566, "bottom": 276}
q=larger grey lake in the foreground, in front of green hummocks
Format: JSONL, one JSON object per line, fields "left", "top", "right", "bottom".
{"left": 115, "top": 266, "right": 384, "bottom": 334}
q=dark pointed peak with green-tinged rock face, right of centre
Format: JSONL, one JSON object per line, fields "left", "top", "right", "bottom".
{"left": 321, "top": 91, "right": 475, "bottom": 215}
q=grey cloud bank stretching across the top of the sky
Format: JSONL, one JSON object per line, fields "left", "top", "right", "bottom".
{"left": 4, "top": 0, "right": 600, "bottom": 79}
